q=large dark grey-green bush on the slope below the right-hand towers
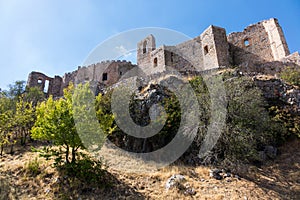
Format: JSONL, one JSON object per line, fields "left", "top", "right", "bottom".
{"left": 191, "top": 74, "right": 284, "bottom": 164}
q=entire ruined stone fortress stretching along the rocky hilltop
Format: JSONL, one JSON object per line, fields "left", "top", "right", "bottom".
{"left": 27, "top": 18, "right": 300, "bottom": 97}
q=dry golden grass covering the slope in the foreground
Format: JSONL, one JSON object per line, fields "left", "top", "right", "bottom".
{"left": 0, "top": 140, "right": 300, "bottom": 200}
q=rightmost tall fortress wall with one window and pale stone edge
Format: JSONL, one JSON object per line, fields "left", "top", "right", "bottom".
{"left": 227, "top": 18, "right": 289, "bottom": 67}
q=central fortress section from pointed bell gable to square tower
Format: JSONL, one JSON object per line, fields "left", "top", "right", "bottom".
{"left": 137, "top": 26, "right": 229, "bottom": 74}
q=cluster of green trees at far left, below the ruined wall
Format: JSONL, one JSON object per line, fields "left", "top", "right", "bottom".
{"left": 0, "top": 81, "right": 44, "bottom": 154}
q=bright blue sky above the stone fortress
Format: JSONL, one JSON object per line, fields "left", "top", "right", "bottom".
{"left": 0, "top": 0, "right": 300, "bottom": 89}
